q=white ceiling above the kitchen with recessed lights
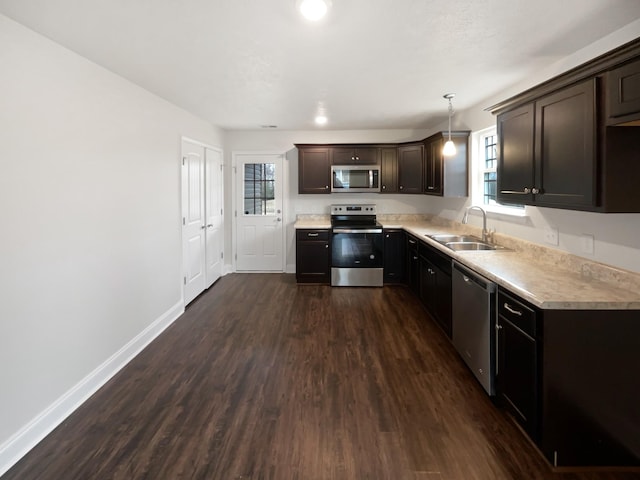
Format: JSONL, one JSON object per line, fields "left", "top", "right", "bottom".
{"left": 0, "top": 0, "right": 640, "bottom": 130}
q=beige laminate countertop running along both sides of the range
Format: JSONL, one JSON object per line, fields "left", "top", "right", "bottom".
{"left": 295, "top": 219, "right": 640, "bottom": 312}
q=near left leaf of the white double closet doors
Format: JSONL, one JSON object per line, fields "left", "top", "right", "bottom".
{"left": 182, "top": 141, "right": 206, "bottom": 305}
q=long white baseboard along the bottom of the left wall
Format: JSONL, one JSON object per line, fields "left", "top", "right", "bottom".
{"left": 0, "top": 298, "right": 184, "bottom": 476}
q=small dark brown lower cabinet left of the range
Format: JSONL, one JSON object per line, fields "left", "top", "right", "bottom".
{"left": 296, "top": 229, "right": 331, "bottom": 284}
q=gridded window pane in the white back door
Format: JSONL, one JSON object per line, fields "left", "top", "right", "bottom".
{"left": 244, "top": 163, "right": 276, "bottom": 215}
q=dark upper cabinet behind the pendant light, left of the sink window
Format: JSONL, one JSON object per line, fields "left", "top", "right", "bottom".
{"left": 423, "top": 130, "right": 471, "bottom": 197}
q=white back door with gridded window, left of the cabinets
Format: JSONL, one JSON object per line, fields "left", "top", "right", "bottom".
{"left": 234, "top": 154, "right": 284, "bottom": 272}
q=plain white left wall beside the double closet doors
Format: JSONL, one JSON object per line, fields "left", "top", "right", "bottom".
{"left": 0, "top": 16, "right": 222, "bottom": 475}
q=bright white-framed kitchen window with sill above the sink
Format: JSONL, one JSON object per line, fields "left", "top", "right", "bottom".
{"left": 471, "top": 127, "right": 525, "bottom": 217}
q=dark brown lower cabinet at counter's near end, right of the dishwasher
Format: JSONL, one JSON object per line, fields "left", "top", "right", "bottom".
{"left": 496, "top": 288, "right": 640, "bottom": 467}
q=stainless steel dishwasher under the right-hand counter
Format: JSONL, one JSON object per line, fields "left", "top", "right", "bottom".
{"left": 451, "top": 260, "right": 496, "bottom": 395}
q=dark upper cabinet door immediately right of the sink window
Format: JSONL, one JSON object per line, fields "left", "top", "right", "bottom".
{"left": 497, "top": 103, "right": 535, "bottom": 204}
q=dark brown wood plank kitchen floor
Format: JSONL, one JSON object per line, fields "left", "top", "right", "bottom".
{"left": 2, "top": 274, "right": 640, "bottom": 480}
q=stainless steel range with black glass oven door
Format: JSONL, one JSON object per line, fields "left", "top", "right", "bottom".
{"left": 331, "top": 204, "right": 383, "bottom": 287}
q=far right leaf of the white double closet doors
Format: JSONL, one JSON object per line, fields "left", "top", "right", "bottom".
{"left": 205, "top": 148, "right": 224, "bottom": 288}
